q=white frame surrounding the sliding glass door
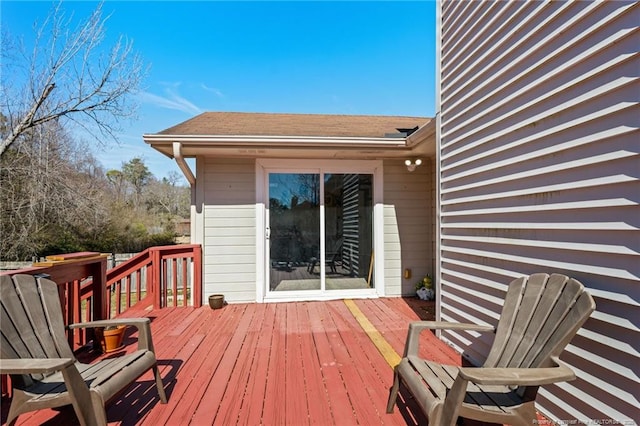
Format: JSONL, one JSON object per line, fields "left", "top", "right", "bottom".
{"left": 255, "top": 158, "right": 385, "bottom": 303}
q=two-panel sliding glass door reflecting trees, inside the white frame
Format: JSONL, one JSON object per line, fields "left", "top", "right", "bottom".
{"left": 266, "top": 171, "right": 374, "bottom": 293}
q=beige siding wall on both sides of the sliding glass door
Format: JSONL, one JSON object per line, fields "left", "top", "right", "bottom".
{"left": 200, "top": 157, "right": 435, "bottom": 302}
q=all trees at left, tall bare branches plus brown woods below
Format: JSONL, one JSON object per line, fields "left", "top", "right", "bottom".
{"left": 0, "top": 1, "right": 190, "bottom": 261}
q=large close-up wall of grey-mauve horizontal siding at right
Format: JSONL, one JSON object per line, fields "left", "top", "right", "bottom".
{"left": 438, "top": 0, "right": 640, "bottom": 424}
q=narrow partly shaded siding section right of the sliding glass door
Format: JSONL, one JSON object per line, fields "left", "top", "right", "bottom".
{"left": 384, "top": 158, "right": 435, "bottom": 296}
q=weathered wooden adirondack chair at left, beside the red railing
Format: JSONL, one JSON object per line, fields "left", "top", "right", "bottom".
{"left": 0, "top": 274, "right": 167, "bottom": 426}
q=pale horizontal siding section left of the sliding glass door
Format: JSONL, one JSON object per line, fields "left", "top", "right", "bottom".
{"left": 202, "top": 158, "right": 256, "bottom": 302}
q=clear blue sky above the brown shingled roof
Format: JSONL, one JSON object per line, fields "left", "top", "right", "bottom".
{"left": 0, "top": 0, "right": 436, "bottom": 177}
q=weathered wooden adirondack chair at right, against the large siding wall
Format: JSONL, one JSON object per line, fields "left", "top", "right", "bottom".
{"left": 387, "top": 274, "right": 595, "bottom": 426}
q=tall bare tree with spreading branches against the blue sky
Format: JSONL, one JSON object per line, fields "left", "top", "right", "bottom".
{"left": 0, "top": 2, "right": 145, "bottom": 155}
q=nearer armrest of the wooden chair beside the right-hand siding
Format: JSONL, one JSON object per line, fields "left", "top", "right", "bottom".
{"left": 458, "top": 364, "right": 576, "bottom": 386}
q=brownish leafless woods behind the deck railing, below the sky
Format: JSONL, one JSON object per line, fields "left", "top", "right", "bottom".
{"left": 0, "top": 115, "right": 190, "bottom": 261}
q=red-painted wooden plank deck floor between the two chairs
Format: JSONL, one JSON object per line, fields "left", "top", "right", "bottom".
{"left": 2, "top": 298, "right": 524, "bottom": 426}
